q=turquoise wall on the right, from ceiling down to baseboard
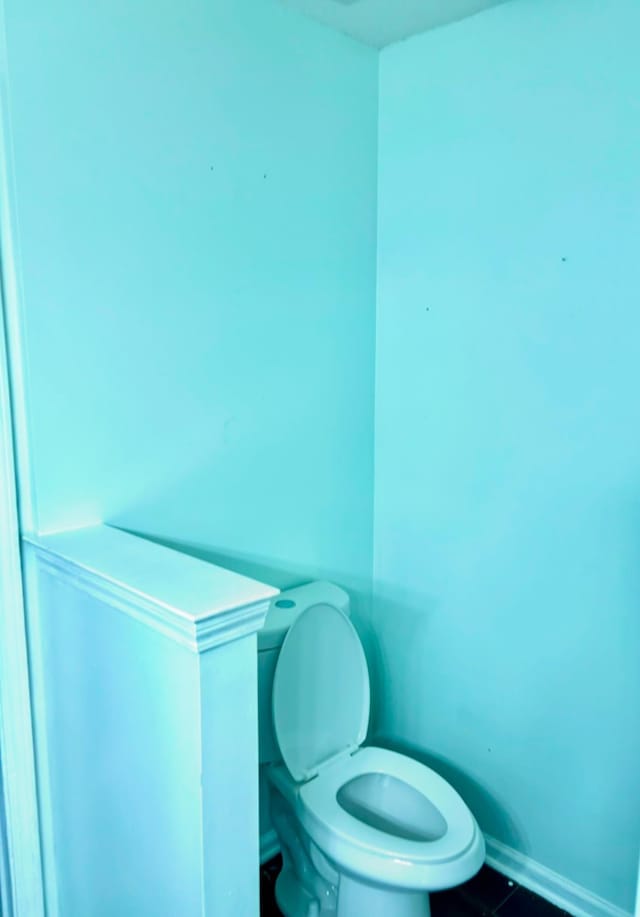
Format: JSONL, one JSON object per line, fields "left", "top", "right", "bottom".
{"left": 375, "top": 0, "right": 640, "bottom": 910}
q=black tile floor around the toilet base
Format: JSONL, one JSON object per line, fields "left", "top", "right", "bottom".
{"left": 260, "top": 857, "right": 568, "bottom": 917}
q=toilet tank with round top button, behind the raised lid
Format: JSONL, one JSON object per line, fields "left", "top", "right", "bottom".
{"left": 258, "top": 581, "right": 350, "bottom": 765}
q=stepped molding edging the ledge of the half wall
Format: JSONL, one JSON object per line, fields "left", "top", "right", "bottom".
{"left": 23, "top": 530, "right": 277, "bottom": 653}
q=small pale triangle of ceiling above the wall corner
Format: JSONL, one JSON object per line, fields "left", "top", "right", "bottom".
{"left": 280, "top": 0, "right": 504, "bottom": 48}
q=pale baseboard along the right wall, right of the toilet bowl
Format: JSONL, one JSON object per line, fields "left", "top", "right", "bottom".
{"left": 485, "top": 836, "right": 632, "bottom": 917}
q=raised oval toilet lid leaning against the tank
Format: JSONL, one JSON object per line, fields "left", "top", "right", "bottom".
{"left": 273, "top": 603, "right": 370, "bottom": 781}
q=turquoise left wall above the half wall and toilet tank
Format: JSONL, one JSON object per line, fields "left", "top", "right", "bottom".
{"left": 5, "top": 0, "right": 377, "bottom": 612}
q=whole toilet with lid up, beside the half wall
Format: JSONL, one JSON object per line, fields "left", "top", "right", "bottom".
{"left": 260, "top": 583, "right": 485, "bottom": 917}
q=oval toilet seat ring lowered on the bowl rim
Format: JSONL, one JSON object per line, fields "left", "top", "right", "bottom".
{"left": 298, "top": 747, "right": 484, "bottom": 890}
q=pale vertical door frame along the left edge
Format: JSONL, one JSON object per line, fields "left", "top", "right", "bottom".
{"left": 0, "top": 0, "right": 45, "bottom": 917}
